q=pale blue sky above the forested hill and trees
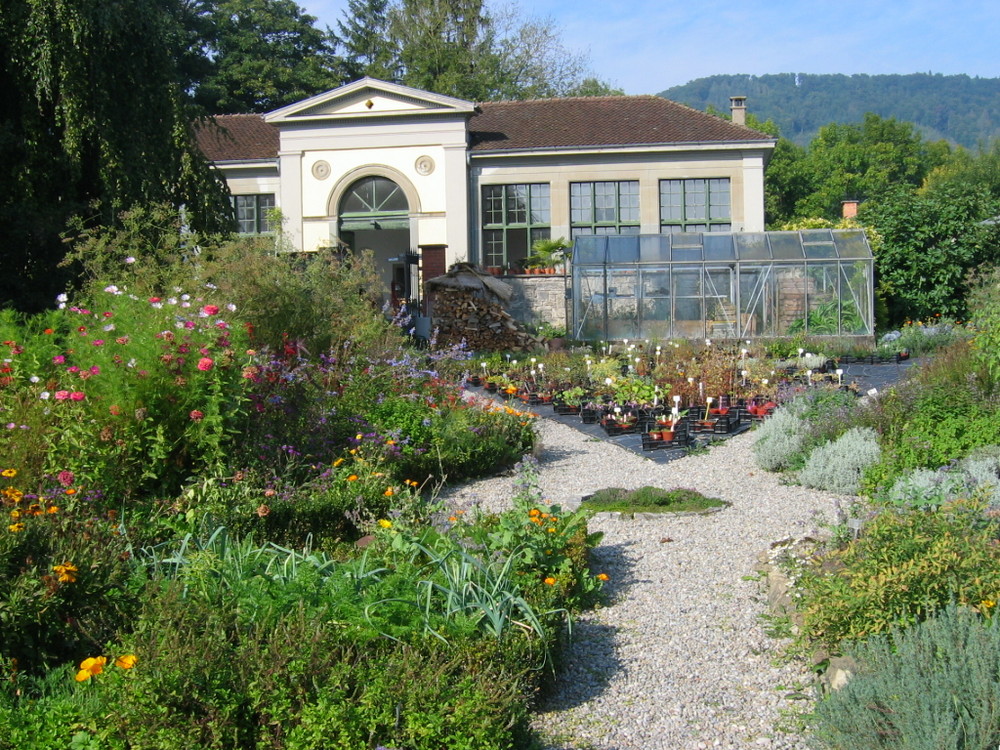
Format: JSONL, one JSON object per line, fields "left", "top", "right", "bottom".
{"left": 298, "top": 0, "right": 1000, "bottom": 94}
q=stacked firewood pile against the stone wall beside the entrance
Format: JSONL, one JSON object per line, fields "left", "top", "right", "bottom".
{"left": 433, "top": 289, "right": 543, "bottom": 351}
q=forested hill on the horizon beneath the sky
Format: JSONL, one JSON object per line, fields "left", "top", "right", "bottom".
{"left": 660, "top": 73, "right": 1000, "bottom": 148}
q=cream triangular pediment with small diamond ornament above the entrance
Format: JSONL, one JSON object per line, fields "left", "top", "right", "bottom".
{"left": 264, "top": 78, "right": 475, "bottom": 125}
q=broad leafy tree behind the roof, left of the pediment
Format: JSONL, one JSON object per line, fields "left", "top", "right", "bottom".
{"left": 195, "top": 0, "right": 345, "bottom": 114}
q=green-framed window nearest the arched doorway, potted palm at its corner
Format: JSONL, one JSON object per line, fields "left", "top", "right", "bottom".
{"left": 483, "top": 182, "right": 552, "bottom": 269}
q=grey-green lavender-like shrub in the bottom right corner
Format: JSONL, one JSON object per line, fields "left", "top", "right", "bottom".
{"left": 813, "top": 605, "right": 1000, "bottom": 750}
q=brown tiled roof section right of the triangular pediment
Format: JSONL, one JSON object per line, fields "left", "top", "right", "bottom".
{"left": 469, "top": 96, "right": 771, "bottom": 151}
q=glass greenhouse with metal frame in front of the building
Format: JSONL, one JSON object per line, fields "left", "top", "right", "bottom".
{"left": 572, "top": 229, "right": 873, "bottom": 341}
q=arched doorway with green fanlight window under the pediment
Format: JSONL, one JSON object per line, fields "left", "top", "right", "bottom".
{"left": 337, "top": 175, "right": 410, "bottom": 308}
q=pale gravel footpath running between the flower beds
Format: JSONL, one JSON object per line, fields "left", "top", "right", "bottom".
{"left": 444, "top": 419, "right": 836, "bottom": 750}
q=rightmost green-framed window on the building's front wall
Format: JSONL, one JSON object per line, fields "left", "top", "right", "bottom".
{"left": 660, "top": 177, "right": 733, "bottom": 234}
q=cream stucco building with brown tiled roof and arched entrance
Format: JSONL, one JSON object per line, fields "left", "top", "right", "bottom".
{"left": 200, "top": 78, "right": 775, "bottom": 306}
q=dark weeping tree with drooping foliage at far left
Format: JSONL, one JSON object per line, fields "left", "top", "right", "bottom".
{"left": 0, "top": 0, "right": 228, "bottom": 309}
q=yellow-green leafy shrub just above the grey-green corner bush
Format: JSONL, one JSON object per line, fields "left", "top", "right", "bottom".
{"left": 800, "top": 501, "right": 1000, "bottom": 649}
